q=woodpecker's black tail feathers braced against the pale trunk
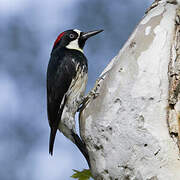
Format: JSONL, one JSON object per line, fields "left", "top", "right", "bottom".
{"left": 72, "top": 132, "right": 91, "bottom": 168}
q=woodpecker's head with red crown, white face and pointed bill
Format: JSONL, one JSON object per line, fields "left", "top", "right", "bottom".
{"left": 53, "top": 29, "right": 103, "bottom": 52}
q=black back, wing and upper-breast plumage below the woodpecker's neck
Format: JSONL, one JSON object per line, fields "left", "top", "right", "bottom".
{"left": 47, "top": 48, "right": 88, "bottom": 154}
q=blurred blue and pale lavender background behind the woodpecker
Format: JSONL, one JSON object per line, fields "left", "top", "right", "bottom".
{"left": 0, "top": 0, "right": 152, "bottom": 180}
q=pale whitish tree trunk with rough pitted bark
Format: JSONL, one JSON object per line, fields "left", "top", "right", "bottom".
{"left": 80, "top": 0, "right": 180, "bottom": 180}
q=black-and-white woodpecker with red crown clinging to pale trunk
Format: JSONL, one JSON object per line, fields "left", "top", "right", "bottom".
{"left": 46, "top": 29, "right": 103, "bottom": 163}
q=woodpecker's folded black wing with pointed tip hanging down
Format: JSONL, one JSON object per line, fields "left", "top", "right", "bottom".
{"left": 47, "top": 53, "right": 76, "bottom": 155}
